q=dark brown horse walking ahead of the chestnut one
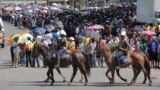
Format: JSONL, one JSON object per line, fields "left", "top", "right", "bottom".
{"left": 36, "top": 44, "right": 90, "bottom": 86}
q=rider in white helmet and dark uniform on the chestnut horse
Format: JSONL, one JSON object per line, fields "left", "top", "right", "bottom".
{"left": 114, "top": 31, "right": 130, "bottom": 69}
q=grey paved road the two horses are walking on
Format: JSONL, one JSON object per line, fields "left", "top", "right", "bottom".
{"left": 0, "top": 23, "right": 160, "bottom": 90}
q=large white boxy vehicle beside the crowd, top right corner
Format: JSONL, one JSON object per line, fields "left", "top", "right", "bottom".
{"left": 136, "top": 0, "right": 160, "bottom": 23}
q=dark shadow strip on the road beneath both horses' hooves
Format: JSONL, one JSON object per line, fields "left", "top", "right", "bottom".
{"left": 9, "top": 81, "right": 160, "bottom": 87}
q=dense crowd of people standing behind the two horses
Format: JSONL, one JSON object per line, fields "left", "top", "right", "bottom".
{"left": 2, "top": 5, "right": 160, "bottom": 68}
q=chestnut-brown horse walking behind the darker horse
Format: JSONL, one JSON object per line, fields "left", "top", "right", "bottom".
{"left": 97, "top": 40, "right": 152, "bottom": 86}
